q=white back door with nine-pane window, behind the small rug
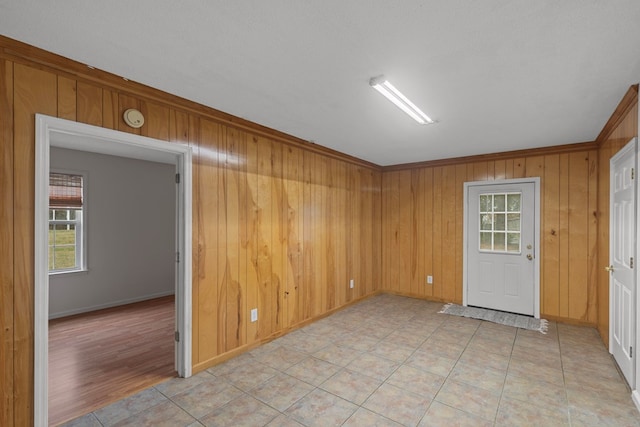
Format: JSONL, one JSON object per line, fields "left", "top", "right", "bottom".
{"left": 465, "top": 182, "right": 539, "bottom": 317}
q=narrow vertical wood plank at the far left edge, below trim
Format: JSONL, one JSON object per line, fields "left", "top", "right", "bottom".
{"left": 0, "top": 61, "right": 14, "bottom": 426}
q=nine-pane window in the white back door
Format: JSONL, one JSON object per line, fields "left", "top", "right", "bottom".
{"left": 479, "top": 193, "right": 522, "bottom": 253}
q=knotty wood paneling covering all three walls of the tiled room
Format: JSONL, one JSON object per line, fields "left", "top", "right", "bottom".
{"left": 0, "top": 37, "right": 638, "bottom": 426}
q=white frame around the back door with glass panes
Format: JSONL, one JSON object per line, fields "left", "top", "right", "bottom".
{"left": 462, "top": 177, "right": 540, "bottom": 319}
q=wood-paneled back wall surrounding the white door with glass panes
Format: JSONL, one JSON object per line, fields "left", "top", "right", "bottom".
{"left": 382, "top": 147, "right": 598, "bottom": 325}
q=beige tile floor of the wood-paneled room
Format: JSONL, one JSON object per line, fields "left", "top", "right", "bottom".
{"left": 60, "top": 295, "right": 640, "bottom": 427}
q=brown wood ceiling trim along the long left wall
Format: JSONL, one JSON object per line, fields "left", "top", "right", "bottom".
{"left": 0, "top": 35, "right": 381, "bottom": 171}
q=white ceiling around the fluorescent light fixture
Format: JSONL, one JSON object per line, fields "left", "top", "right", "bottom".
{"left": 0, "top": 0, "right": 640, "bottom": 165}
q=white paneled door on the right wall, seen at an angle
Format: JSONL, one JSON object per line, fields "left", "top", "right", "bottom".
{"left": 606, "top": 139, "right": 636, "bottom": 385}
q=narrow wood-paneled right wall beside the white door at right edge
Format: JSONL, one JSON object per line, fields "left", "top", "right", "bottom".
{"left": 595, "top": 85, "right": 638, "bottom": 346}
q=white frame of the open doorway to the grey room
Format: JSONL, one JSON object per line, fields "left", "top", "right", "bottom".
{"left": 33, "top": 114, "right": 192, "bottom": 426}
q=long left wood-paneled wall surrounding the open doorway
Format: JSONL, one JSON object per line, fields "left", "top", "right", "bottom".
{"left": 0, "top": 37, "right": 381, "bottom": 426}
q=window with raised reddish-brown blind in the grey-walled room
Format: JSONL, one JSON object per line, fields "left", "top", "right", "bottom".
{"left": 49, "top": 172, "right": 85, "bottom": 273}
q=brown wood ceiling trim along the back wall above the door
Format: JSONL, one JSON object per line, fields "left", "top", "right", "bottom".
{"left": 382, "top": 141, "right": 598, "bottom": 172}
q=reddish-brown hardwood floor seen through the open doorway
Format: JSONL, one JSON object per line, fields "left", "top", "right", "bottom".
{"left": 49, "top": 296, "right": 175, "bottom": 426}
